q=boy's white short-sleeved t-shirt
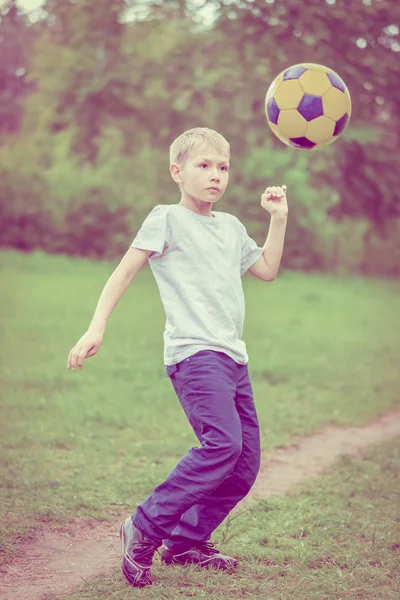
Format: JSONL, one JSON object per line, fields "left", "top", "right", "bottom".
{"left": 131, "top": 204, "right": 263, "bottom": 365}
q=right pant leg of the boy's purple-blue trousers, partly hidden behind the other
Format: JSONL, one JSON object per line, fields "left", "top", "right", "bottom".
{"left": 164, "top": 365, "right": 261, "bottom": 547}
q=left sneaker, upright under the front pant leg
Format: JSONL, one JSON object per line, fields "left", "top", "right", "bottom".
{"left": 119, "top": 517, "right": 158, "bottom": 587}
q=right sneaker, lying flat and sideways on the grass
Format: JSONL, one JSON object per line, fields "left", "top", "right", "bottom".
{"left": 161, "top": 541, "right": 238, "bottom": 570}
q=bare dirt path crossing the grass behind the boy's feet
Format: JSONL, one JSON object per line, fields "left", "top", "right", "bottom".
{"left": 0, "top": 411, "right": 400, "bottom": 600}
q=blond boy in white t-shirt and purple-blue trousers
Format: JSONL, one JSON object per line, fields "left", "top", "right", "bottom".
{"left": 67, "top": 128, "right": 288, "bottom": 587}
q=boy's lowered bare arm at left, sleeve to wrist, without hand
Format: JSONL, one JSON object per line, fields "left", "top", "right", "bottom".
{"left": 88, "top": 248, "right": 152, "bottom": 333}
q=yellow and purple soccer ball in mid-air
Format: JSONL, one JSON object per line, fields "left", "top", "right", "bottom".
{"left": 265, "top": 63, "right": 351, "bottom": 150}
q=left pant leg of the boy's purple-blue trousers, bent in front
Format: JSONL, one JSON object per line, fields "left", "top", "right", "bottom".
{"left": 132, "top": 350, "right": 242, "bottom": 543}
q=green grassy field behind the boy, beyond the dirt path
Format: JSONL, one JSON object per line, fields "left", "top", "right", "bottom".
{"left": 0, "top": 252, "right": 400, "bottom": 600}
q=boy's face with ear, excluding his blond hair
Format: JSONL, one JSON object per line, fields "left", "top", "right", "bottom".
{"left": 171, "top": 144, "right": 229, "bottom": 203}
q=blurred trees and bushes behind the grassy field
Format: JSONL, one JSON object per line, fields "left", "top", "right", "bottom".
{"left": 0, "top": 0, "right": 400, "bottom": 274}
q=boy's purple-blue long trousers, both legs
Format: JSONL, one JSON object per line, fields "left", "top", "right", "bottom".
{"left": 132, "top": 350, "right": 260, "bottom": 550}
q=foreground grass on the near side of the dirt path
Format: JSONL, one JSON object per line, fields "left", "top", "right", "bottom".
{"left": 54, "top": 442, "right": 400, "bottom": 600}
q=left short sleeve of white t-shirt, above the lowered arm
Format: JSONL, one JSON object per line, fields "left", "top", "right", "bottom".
{"left": 131, "top": 204, "right": 169, "bottom": 256}
